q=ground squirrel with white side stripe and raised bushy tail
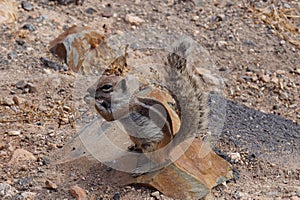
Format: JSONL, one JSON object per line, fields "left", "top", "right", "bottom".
{"left": 88, "top": 40, "right": 209, "bottom": 173}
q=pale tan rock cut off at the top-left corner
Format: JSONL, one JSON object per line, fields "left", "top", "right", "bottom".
{"left": 0, "top": 0, "right": 18, "bottom": 24}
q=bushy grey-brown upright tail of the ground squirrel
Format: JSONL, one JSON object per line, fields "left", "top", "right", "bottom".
{"left": 166, "top": 40, "right": 209, "bottom": 146}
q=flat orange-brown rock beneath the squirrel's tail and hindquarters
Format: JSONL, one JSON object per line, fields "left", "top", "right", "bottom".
{"left": 111, "top": 139, "right": 233, "bottom": 199}
